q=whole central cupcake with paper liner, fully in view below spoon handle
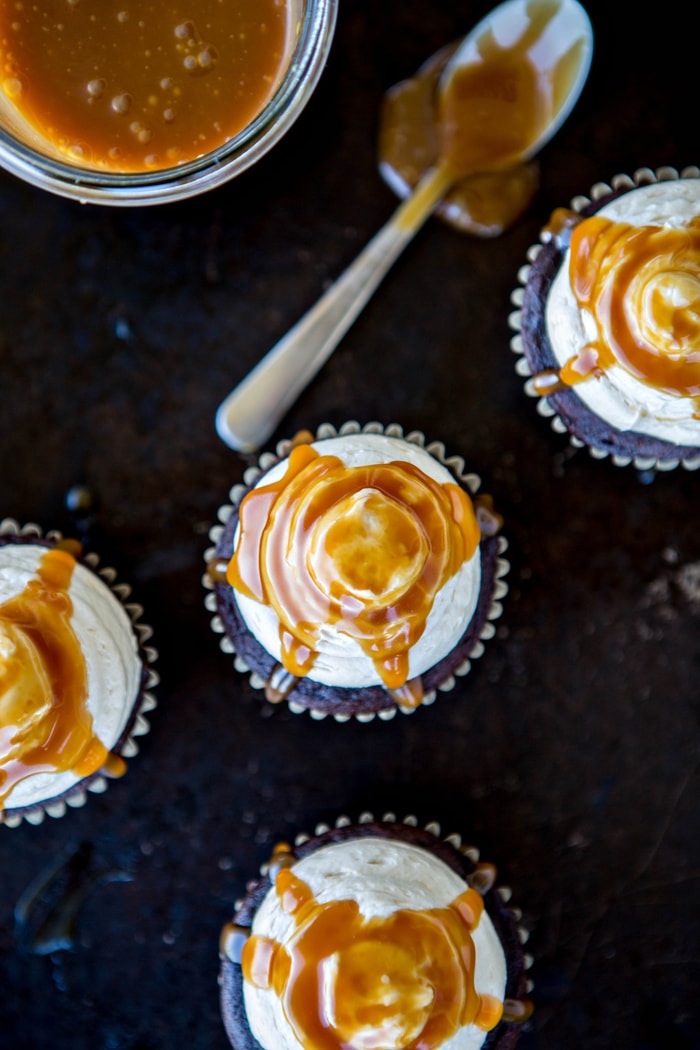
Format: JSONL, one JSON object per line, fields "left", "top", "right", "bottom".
{"left": 205, "top": 422, "right": 508, "bottom": 720}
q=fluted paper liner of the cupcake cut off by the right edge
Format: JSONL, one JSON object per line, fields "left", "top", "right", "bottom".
{"left": 508, "top": 167, "right": 700, "bottom": 471}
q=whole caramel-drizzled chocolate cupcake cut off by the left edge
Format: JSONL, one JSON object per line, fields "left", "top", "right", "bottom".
{"left": 0, "top": 519, "right": 157, "bottom": 826}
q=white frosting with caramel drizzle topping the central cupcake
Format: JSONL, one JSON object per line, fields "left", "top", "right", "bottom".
{"left": 227, "top": 434, "right": 481, "bottom": 701}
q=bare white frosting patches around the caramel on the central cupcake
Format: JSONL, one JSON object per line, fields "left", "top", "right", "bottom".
{"left": 229, "top": 434, "right": 481, "bottom": 688}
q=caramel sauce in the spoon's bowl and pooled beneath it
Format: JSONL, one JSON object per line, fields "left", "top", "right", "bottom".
{"left": 379, "top": 0, "right": 586, "bottom": 236}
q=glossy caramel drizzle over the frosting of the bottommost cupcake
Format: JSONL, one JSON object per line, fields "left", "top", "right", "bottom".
{"left": 241, "top": 868, "right": 503, "bottom": 1050}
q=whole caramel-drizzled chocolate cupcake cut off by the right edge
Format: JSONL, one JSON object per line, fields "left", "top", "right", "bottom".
{"left": 510, "top": 167, "right": 700, "bottom": 470}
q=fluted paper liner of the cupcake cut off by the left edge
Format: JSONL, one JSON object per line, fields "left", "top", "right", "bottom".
{"left": 0, "top": 518, "right": 160, "bottom": 827}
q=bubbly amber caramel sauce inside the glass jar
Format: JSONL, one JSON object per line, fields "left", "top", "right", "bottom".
{"left": 0, "top": 0, "right": 293, "bottom": 172}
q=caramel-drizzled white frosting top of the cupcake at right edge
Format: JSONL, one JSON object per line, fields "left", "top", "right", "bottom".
{"left": 538, "top": 179, "right": 700, "bottom": 445}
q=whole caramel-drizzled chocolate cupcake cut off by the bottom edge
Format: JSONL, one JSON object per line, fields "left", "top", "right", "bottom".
{"left": 219, "top": 814, "right": 532, "bottom": 1050}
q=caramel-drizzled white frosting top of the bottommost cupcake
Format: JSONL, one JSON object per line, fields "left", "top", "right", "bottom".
{"left": 243, "top": 839, "right": 506, "bottom": 1050}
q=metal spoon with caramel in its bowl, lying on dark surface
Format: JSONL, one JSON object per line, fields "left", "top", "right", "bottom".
{"left": 216, "top": 0, "right": 593, "bottom": 452}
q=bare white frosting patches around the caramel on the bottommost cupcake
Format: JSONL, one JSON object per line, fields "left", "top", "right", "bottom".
{"left": 243, "top": 837, "right": 507, "bottom": 1050}
